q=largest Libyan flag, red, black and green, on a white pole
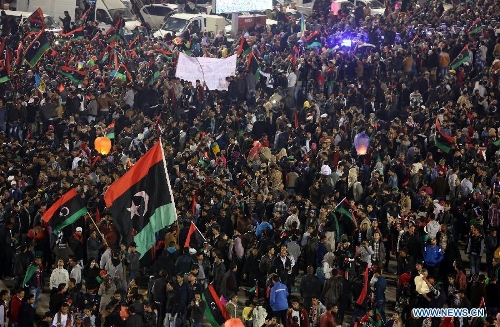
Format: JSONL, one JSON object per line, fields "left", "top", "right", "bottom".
{"left": 104, "top": 142, "right": 177, "bottom": 257}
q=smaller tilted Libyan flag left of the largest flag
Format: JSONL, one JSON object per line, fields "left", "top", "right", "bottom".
{"left": 42, "top": 188, "right": 88, "bottom": 235}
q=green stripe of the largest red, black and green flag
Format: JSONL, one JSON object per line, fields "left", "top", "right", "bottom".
{"left": 134, "top": 203, "right": 176, "bottom": 258}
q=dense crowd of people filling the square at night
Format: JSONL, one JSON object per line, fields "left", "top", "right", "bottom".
{"left": 0, "top": 0, "right": 500, "bottom": 327}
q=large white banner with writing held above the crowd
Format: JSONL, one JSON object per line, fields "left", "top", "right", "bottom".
{"left": 175, "top": 53, "right": 236, "bottom": 91}
